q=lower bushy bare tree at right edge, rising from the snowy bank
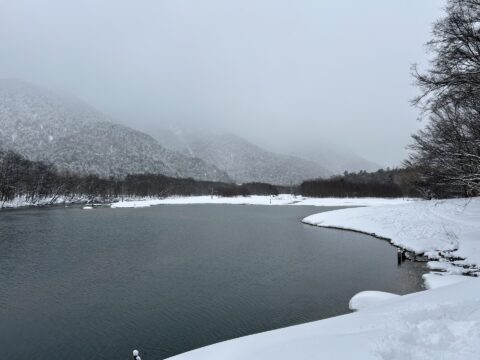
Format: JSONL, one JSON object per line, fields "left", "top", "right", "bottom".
{"left": 408, "top": 103, "right": 480, "bottom": 197}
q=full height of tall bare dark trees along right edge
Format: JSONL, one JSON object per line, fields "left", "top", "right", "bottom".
{"left": 407, "top": 0, "right": 480, "bottom": 197}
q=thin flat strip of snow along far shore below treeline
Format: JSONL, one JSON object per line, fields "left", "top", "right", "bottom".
{"left": 111, "top": 194, "right": 412, "bottom": 208}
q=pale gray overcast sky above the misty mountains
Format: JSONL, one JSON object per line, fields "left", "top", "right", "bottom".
{"left": 0, "top": 0, "right": 444, "bottom": 165}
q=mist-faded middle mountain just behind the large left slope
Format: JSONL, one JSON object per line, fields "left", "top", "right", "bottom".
{"left": 148, "top": 129, "right": 332, "bottom": 185}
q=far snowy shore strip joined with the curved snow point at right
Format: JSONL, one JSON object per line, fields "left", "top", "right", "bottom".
{"left": 111, "top": 194, "right": 480, "bottom": 274}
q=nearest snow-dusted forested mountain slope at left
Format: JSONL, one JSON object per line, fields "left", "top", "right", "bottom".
{"left": 0, "top": 79, "right": 231, "bottom": 181}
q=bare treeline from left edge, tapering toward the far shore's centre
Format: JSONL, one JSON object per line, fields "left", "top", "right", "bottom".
{"left": 0, "top": 151, "right": 283, "bottom": 204}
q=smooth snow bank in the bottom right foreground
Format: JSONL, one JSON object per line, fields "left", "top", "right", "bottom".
{"left": 170, "top": 277, "right": 480, "bottom": 360}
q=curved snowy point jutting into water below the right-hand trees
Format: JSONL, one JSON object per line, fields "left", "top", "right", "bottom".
{"left": 303, "top": 198, "right": 480, "bottom": 273}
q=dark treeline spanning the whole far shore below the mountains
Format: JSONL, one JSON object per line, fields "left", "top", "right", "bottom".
{"left": 0, "top": 151, "right": 418, "bottom": 204}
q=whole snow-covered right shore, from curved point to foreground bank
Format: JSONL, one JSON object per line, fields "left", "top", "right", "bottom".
{"left": 166, "top": 198, "right": 480, "bottom": 360}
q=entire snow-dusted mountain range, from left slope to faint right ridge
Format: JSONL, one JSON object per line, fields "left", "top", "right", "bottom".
{"left": 0, "top": 79, "right": 379, "bottom": 185}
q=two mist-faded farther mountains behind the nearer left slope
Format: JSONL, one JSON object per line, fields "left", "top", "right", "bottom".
{"left": 150, "top": 126, "right": 381, "bottom": 184}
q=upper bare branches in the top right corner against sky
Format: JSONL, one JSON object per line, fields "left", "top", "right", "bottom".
{"left": 413, "top": 0, "right": 480, "bottom": 110}
